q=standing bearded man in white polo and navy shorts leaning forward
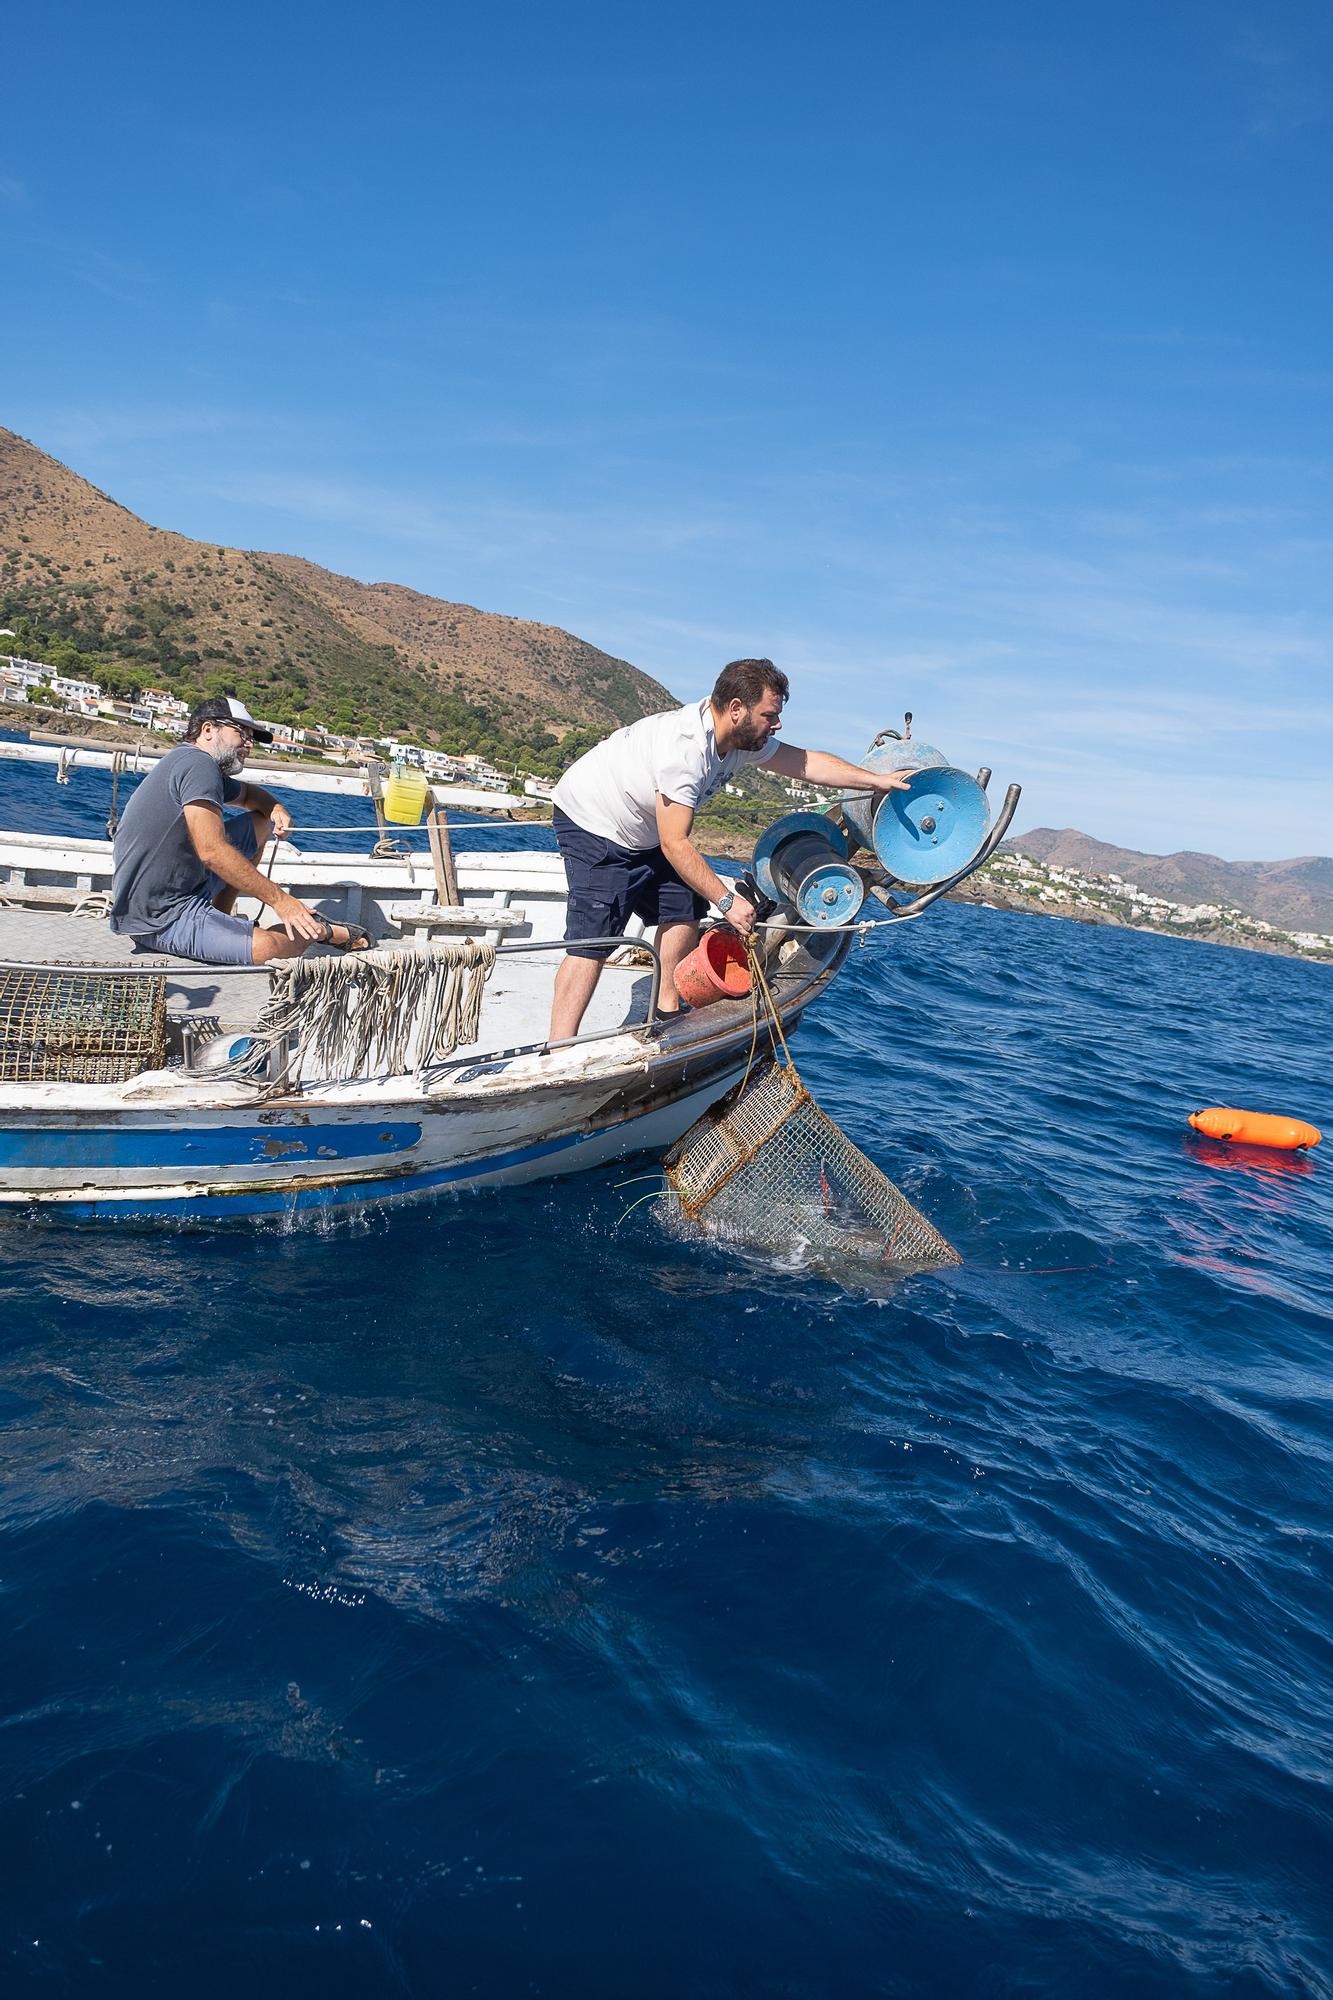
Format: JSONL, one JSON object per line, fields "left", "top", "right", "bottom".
{"left": 550, "top": 660, "right": 909, "bottom": 1042}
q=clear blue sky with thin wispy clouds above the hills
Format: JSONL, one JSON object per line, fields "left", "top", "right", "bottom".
{"left": 0, "top": 0, "right": 1333, "bottom": 858}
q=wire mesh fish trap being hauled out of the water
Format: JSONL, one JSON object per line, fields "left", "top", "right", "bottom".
{"left": 662, "top": 1062, "right": 963, "bottom": 1270}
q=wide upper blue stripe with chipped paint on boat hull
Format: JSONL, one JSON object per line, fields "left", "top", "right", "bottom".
{"left": 0, "top": 1124, "right": 420, "bottom": 1176}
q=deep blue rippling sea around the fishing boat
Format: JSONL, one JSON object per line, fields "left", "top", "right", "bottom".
{"left": 0, "top": 744, "right": 1333, "bottom": 2000}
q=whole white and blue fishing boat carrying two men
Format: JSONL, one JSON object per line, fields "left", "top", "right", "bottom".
{"left": 0, "top": 724, "right": 1017, "bottom": 1218}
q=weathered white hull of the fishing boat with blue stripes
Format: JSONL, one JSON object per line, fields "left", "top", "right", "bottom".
{"left": 0, "top": 834, "right": 851, "bottom": 1220}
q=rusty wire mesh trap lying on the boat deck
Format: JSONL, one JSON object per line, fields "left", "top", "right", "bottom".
{"left": 0, "top": 966, "right": 166, "bottom": 1084}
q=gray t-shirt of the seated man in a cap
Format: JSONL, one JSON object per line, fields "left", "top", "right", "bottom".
{"left": 110, "top": 744, "right": 244, "bottom": 938}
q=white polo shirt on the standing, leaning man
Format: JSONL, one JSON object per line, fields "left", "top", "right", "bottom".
{"left": 552, "top": 696, "right": 779, "bottom": 852}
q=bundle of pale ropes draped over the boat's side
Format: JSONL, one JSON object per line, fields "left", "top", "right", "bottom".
{"left": 256, "top": 938, "right": 494, "bottom": 1078}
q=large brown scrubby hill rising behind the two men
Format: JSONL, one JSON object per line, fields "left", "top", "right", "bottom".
{"left": 0, "top": 428, "right": 673, "bottom": 752}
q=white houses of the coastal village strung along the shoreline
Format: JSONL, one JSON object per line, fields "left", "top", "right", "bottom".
{"left": 0, "top": 630, "right": 1333, "bottom": 964}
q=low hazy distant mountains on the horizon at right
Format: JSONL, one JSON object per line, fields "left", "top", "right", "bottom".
{"left": 1001, "top": 826, "right": 1333, "bottom": 932}
